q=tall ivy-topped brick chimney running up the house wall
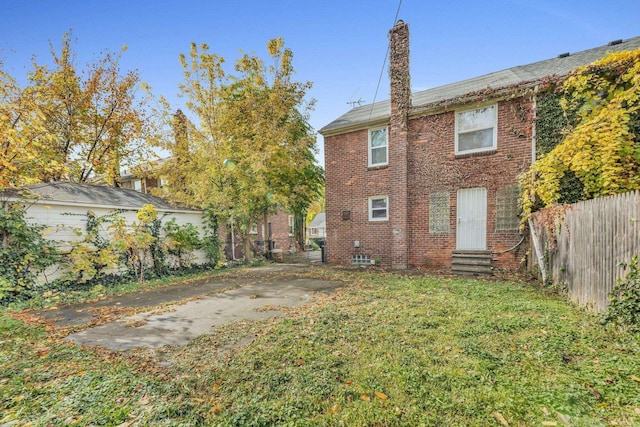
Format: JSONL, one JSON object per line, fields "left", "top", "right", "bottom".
{"left": 388, "top": 21, "right": 411, "bottom": 270}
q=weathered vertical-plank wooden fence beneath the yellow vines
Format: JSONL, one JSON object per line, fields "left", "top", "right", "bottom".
{"left": 532, "top": 191, "right": 640, "bottom": 313}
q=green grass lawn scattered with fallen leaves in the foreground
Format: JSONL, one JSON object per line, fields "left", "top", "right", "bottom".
{"left": 0, "top": 268, "right": 640, "bottom": 426}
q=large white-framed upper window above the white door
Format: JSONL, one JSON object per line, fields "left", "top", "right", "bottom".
{"left": 456, "top": 104, "right": 498, "bottom": 154}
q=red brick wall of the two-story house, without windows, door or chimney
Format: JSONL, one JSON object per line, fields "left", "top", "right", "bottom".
{"left": 325, "top": 99, "right": 531, "bottom": 269}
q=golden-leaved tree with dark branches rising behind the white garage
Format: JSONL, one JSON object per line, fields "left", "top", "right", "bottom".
{"left": 23, "top": 32, "right": 155, "bottom": 186}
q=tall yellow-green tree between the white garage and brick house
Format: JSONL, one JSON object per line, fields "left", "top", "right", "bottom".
{"left": 160, "top": 38, "right": 324, "bottom": 258}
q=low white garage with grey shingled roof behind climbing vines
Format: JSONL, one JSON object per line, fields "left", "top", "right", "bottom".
{"left": 2, "top": 182, "right": 207, "bottom": 280}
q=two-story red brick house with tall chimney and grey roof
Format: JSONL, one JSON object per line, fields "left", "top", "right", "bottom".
{"left": 320, "top": 21, "right": 640, "bottom": 273}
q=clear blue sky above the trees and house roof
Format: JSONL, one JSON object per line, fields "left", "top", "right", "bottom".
{"left": 0, "top": 0, "right": 640, "bottom": 164}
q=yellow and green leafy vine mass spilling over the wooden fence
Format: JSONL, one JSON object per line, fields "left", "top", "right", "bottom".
{"left": 521, "top": 50, "right": 640, "bottom": 218}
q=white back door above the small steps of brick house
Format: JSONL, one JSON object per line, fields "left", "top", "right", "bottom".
{"left": 456, "top": 188, "right": 487, "bottom": 250}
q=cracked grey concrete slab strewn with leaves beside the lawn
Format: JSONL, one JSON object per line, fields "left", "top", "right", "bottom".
{"left": 39, "top": 264, "right": 345, "bottom": 350}
